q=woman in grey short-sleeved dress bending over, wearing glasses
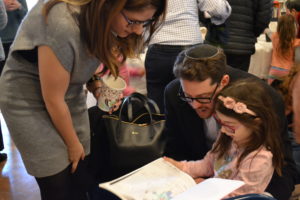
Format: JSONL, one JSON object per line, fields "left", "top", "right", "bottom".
{"left": 0, "top": 0, "right": 166, "bottom": 200}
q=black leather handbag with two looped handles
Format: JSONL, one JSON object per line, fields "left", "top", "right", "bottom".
{"left": 103, "top": 93, "right": 165, "bottom": 171}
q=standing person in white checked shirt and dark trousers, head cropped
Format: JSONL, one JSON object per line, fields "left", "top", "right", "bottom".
{"left": 145, "top": 0, "right": 231, "bottom": 111}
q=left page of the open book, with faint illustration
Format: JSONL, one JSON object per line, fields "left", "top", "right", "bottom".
{"left": 99, "top": 158, "right": 196, "bottom": 200}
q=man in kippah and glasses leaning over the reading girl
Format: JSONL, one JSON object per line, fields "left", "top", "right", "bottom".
{"left": 165, "top": 45, "right": 297, "bottom": 200}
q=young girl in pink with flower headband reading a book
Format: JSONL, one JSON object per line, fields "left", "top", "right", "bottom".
{"left": 165, "top": 80, "right": 283, "bottom": 197}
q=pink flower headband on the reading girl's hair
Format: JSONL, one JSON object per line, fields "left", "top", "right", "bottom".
{"left": 218, "top": 96, "right": 256, "bottom": 116}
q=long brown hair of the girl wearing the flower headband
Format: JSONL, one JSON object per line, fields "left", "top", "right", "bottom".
{"left": 212, "top": 79, "right": 284, "bottom": 175}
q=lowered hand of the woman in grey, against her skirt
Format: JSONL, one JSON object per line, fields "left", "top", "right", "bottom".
{"left": 68, "top": 141, "right": 85, "bottom": 173}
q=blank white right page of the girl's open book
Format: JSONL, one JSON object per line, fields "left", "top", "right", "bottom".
{"left": 172, "top": 178, "right": 245, "bottom": 200}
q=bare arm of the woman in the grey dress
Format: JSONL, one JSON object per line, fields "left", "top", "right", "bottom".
{"left": 38, "top": 46, "right": 85, "bottom": 172}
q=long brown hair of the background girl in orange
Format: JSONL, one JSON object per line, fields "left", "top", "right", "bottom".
{"left": 276, "top": 14, "right": 297, "bottom": 58}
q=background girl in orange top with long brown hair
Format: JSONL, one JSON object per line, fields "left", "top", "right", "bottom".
{"left": 266, "top": 14, "right": 300, "bottom": 84}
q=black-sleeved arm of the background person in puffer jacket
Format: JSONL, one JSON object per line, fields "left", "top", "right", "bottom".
{"left": 253, "top": 0, "right": 273, "bottom": 37}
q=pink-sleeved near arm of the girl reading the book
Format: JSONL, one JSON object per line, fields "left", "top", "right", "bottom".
{"left": 227, "top": 149, "right": 274, "bottom": 197}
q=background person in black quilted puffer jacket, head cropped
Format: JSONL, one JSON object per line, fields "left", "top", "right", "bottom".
{"left": 206, "top": 0, "right": 273, "bottom": 72}
